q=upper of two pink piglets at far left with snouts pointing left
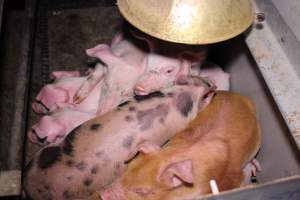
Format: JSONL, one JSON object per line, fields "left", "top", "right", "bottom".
{"left": 32, "top": 67, "right": 105, "bottom": 114}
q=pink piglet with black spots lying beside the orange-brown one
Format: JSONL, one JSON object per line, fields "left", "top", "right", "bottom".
{"left": 24, "top": 77, "right": 215, "bottom": 200}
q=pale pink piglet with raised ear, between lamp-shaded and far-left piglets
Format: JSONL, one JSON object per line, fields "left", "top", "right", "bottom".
{"left": 73, "top": 32, "right": 147, "bottom": 109}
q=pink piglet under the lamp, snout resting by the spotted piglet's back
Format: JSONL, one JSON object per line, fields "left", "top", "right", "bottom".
{"left": 133, "top": 31, "right": 207, "bottom": 95}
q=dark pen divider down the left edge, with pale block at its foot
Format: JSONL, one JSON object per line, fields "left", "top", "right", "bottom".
{"left": 0, "top": 0, "right": 36, "bottom": 198}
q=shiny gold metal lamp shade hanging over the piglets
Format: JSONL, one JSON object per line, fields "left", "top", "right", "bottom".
{"left": 117, "top": 0, "right": 254, "bottom": 44}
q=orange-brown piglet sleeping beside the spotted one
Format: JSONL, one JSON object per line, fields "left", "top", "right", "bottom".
{"left": 100, "top": 92, "right": 261, "bottom": 200}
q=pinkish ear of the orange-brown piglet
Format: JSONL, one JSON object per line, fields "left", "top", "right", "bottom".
{"left": 158, "top": 159, "right": 194, "bottom": 188}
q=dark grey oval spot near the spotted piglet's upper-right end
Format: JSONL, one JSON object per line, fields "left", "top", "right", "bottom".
{"left": 176, "top": 92, "right": 194, "bottom": 117}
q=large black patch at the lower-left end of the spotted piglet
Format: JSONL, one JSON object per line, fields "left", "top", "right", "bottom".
{"left": 38, "top": 146, "right": 62, "bottom": 169}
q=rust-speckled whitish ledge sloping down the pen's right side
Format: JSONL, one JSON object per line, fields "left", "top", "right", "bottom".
{"left": 246, "top": 1, "right": 300, "bottom": 148}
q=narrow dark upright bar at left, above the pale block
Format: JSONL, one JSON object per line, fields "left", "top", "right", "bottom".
{"left": 8, "top": 0, "right": 36, "bottom": 169}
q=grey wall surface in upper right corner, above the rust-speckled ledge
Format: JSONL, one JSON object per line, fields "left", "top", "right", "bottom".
{"left": 254, "top": 0, "right": 300, "bottom": 79}
